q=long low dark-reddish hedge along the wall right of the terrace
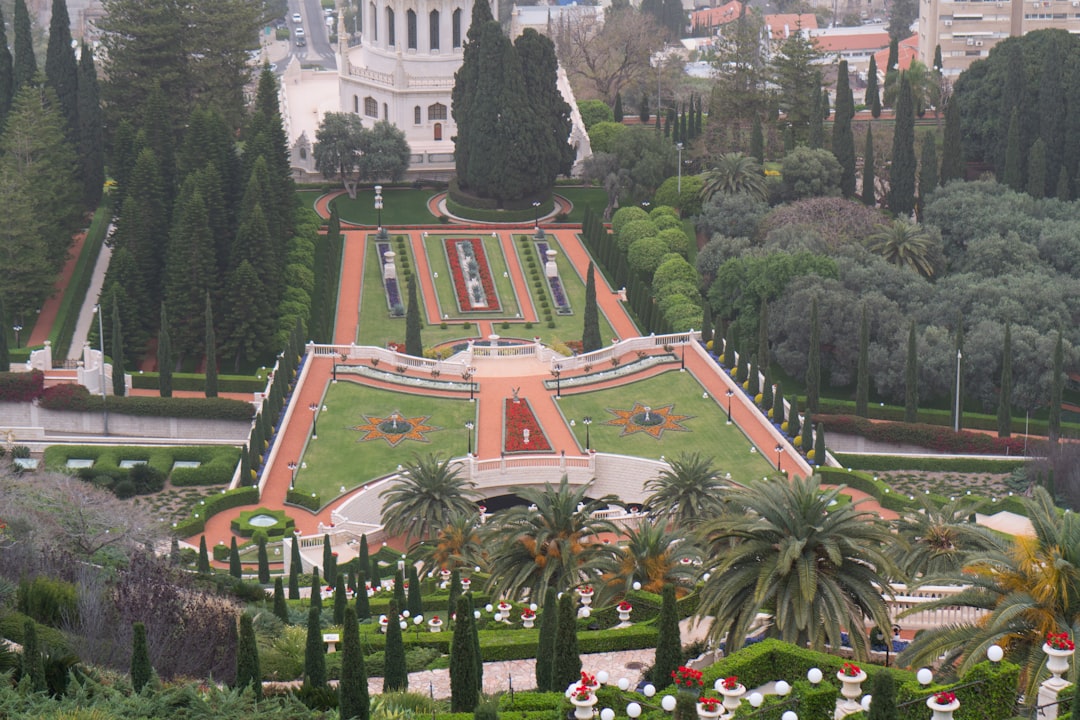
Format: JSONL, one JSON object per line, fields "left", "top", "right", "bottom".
{"left": 813, "top": 415, "right": 1024, "bottom": 456}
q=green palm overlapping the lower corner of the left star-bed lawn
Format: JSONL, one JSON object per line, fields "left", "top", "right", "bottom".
{"left": 379, "top": 454, "right": 477, "bottom": 542}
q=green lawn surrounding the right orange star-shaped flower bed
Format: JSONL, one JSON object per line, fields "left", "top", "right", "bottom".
{"left": 559, "top": 369, "right": 774, "bottom": 483}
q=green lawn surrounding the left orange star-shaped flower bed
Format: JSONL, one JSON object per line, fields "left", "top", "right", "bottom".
{"left": 296, "top": 381, "right": 476, "bottom": 504}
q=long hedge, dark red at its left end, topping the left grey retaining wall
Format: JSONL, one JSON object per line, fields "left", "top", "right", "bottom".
{"left": 40, "top": 384, "right": 254, "bottom": 420}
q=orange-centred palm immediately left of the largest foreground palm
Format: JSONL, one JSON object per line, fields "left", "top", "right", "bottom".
{"left": 600, "top": 519, "right": 701, "bottom": 601}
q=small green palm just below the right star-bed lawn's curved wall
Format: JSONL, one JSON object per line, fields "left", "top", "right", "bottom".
{"left": 644, "top": 452, "right": 729, "bottom": 528}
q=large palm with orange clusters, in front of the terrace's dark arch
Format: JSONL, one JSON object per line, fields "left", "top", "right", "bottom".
{"left": 485, "top": 475, "right": 618, "bottom": 598}
